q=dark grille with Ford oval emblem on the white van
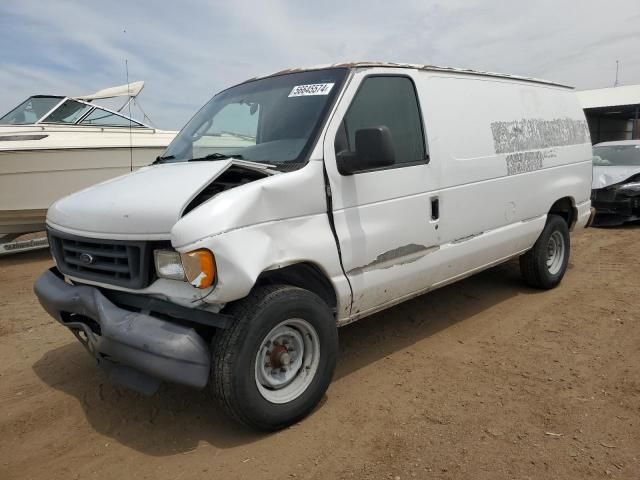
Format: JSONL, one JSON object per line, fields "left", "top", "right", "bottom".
{"left": 48, "top": 229, "right": 152, "bottom": 289}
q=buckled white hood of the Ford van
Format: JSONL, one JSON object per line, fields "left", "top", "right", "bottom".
{"left": 47, "top": 159, "right": 268, "bottom": 239}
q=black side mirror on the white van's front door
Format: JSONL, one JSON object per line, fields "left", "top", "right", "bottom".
{"left": 336, "top": 125, "right": 396, "bottom": 175}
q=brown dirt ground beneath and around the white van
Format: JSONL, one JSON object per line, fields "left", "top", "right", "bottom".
{"left": 0, "top": 226, "right": 640, "bottom": 480}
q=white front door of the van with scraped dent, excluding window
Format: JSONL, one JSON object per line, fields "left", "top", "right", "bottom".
{"left": 324, "top": 69, "right": 439, "bottom": 315}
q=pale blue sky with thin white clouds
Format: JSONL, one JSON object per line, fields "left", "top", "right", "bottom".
{"left": 0, "top": 0, "right": 640, "bottom": 129}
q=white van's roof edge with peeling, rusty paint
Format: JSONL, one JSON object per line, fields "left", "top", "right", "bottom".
{"left": 247, "top": 62, "right": 573, "bottom": 89}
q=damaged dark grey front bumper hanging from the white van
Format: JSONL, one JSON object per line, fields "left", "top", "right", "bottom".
{"left": 34, "top": 269, "right": 210, "bottom": 395}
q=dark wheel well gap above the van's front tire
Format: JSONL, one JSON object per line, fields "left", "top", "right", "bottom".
{"left": 256, "top": 262, "right": 338, "bottom": 309}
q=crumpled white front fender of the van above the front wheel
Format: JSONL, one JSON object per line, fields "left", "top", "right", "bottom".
{"left": 171, "top": 161, "right": 350, "bottom": 316}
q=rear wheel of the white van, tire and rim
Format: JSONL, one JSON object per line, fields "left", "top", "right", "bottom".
{"left": 520, "top": 214, "right": 571, "bottom": 290}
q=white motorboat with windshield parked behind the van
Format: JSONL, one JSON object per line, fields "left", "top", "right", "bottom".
{"left": 0, "top": 81, "right": 177, "bottom": 244}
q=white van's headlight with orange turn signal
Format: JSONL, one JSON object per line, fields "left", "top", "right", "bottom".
{"left": 153, "top": 249, "right": 216, "bottom": 288}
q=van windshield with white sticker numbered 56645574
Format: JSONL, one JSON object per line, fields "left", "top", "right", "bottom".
{"left": 159, "top": 69, "right": 347, "bottom": 165}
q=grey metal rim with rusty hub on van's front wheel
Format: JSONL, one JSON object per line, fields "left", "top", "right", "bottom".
{"left": 255, "top": 318, "right": 320, "bottom": 403}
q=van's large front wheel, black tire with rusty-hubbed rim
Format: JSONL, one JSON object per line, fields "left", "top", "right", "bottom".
{"left": 209, "top": 285, "right": 338, "bottom": 431}
